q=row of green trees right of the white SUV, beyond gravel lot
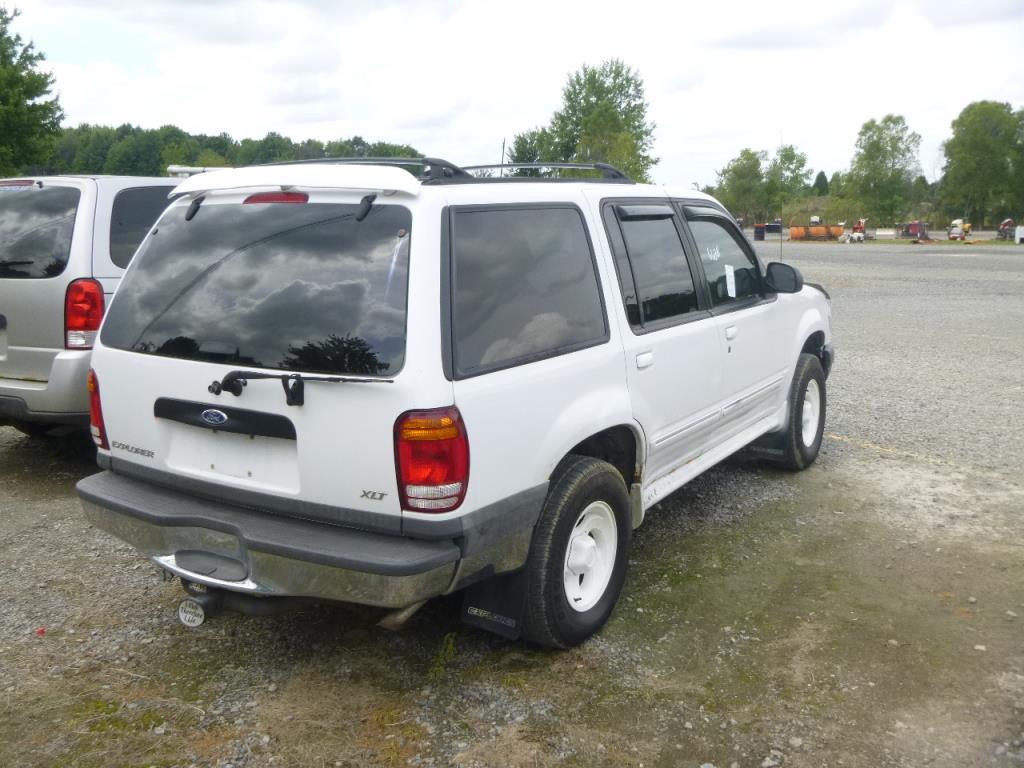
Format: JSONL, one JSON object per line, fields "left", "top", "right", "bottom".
{"left": 706, "top": 107, "right": 1024, "bottom": 226}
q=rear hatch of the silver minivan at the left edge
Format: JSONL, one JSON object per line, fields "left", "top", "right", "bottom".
{"left": 0, "top": 179, "right": 93, "bottom": 382}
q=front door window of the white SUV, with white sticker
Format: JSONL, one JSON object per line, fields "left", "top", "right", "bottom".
{"left": 689, "top": 219, "right": 762, "bottom": 306}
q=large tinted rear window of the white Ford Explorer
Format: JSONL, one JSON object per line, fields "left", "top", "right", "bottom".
{"left": 101, "top": 201, "right": 412, "bottom": 376}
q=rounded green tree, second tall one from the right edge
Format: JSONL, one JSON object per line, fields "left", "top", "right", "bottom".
{"left": 846, "top": 115, "right": 921, "bottom": 224}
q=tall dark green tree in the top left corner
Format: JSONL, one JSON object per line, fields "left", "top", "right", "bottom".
{"left": 0, "top": 7, "right": 63, "bottom": 176}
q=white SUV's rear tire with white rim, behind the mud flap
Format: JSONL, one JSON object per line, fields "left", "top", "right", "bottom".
{"left": 522, "top": 456, "right": 632, "bottom": 648}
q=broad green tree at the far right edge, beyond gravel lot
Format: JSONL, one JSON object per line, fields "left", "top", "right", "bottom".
{"left": 942, "top": 101, "right": 1024, "bottom": 227}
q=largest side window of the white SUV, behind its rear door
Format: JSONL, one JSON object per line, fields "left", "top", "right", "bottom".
{"left": 452, "top": 207, "right": 608, "bottom": 377}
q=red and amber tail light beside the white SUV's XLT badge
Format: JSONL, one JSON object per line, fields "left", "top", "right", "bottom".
{"left": 394, "top": 407, "right": 469, "bottom": 512}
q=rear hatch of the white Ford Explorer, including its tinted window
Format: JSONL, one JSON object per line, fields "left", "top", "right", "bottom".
{"left": 93, "top": 191, "right": 452, "bottom": 530}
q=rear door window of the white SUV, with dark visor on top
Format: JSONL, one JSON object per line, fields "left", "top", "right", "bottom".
{"left": 605, "top": 205, "right": 699, "bottom": 327}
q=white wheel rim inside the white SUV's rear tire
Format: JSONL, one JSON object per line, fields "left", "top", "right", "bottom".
{"left": 562, "top": 501, "right": 618, "bottom": 613}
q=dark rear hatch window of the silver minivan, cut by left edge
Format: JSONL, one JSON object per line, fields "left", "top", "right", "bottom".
{"left": 0, "top": 184, "right": 82, "bottom": 279}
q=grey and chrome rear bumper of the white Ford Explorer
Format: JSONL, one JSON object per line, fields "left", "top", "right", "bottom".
{"left": 77, "top": 471, "right": 529, "bottom": 608}
